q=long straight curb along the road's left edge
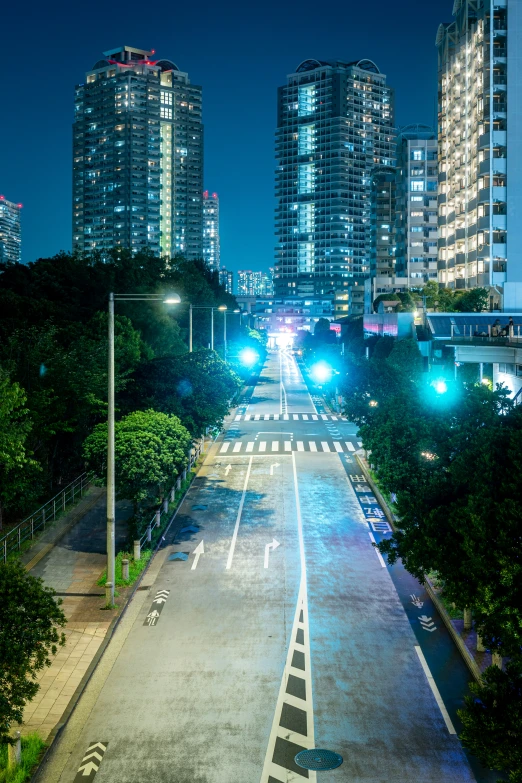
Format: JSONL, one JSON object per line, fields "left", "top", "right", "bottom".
{"left": 29, "top": 450, "right": 207, "bottom": 783}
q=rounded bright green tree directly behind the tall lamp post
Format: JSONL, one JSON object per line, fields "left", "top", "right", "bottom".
{"left": 84, "top": 410, "right": 192, "bottom": 514}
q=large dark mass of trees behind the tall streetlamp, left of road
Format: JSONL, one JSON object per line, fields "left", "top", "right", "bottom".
{"left": 0, "top": 252, "right": 239, "bottom": 521}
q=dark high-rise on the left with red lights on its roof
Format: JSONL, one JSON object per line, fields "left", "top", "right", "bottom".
{"left": 73, "top": 46, "right": 203, "bottom": 259}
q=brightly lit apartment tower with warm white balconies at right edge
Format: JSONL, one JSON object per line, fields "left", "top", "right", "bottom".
{"left": 436, "top": 0, "right": 522, "bottom": 309}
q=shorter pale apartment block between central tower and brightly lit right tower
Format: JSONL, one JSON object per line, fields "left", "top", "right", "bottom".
{"left": 395, "top": 125, "right": 438, "bottom": 288}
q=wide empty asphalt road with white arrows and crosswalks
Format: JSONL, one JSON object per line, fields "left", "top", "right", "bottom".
{"left": 41, "top": 354, "right": 488, "bottom": 783}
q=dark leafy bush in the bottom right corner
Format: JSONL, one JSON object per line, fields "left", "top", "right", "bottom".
{"left": 459, "top": 656, "right": 522, "bottom": 783}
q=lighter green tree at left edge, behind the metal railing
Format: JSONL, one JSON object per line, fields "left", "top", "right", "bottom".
{"left": 0, "top": 369, "right": 38, "bottom": 530}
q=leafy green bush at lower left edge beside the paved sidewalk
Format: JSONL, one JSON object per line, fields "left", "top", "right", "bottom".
{"left": 0, "top": 560, "right": 66, "bottom": 743}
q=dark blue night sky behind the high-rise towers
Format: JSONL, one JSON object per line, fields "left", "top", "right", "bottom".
{"left": 0, "top": 0, "right": 446, "bottom": 270}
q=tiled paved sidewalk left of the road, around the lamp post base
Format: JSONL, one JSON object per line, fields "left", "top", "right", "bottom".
{"left": 21, "top": 496, "right": 132, "bottom": 740}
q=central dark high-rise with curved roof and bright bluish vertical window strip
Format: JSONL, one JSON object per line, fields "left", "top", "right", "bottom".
{"left": 274, "top": 60, "right": 395, "bottom": 304}
